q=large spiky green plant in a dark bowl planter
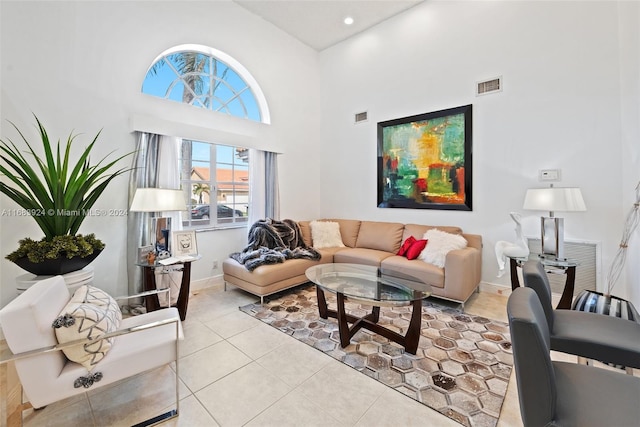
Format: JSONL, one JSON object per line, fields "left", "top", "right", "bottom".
{"left": 0, "top": 115, "right": 129, "bottom": 275}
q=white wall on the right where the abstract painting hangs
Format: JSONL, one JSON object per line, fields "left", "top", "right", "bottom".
{"left": 320, "top": 1, "right": 640, "bottom": 296}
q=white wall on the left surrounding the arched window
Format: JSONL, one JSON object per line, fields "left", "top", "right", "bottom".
{"left": 0, "top": 1, "right": 320, "bottom": 306}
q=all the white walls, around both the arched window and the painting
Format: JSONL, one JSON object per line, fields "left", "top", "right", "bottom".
{"left": 0, "top": 1, "right": 640, "bottom": 306}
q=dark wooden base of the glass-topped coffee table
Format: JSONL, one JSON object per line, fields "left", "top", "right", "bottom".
{"left": 316, "top": 286, "right": 422, "bottom": 354}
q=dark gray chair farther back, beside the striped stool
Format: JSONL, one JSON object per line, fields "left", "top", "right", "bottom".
{"left": 522, "top": 261, "right": 640, "bottom": 368}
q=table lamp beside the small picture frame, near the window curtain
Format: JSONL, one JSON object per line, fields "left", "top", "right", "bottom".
{"left": 129, "top": 188, "right": 187, "bottom": 251}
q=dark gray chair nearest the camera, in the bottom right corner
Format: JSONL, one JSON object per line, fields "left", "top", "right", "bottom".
{"left": 507, "top": 288, "right": 640, "bottom": 427}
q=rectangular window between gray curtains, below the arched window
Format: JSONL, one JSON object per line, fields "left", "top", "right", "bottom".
{"left": 180, "top": 139, "right": 249, "bottom": 228}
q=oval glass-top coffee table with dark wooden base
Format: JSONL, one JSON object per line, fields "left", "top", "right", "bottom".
{"left": 306, "top": 263, "right": 431, "bottom": 354}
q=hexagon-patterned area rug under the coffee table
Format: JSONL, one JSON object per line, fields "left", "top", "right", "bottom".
{"left": 240, "top": 285, "right": 513, "bottom": 426}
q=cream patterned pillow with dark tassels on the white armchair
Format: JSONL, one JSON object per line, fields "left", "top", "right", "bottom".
{"left": 53, "top": 285, "right": 122, "bottom": 371}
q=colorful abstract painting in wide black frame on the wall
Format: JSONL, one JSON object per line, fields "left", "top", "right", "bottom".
{"left": 378, "top": 104, "right": 473, "bottom": 211}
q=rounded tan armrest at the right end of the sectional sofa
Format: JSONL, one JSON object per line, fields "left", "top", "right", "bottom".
{"left": 444, "top": 246, "right": 482, "bottom": 301}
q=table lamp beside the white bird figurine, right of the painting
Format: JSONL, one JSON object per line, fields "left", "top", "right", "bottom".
{"left": 522, "top": 185, "right": 587, "bottom": 259}
